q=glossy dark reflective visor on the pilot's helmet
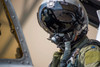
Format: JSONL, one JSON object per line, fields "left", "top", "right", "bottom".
{"left": 41, "top": 9, "right": 75, "bottom": 33}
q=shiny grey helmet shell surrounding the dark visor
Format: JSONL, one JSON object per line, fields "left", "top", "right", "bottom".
{"left": 37, "top": 0, "right": 89, "bottom": 34}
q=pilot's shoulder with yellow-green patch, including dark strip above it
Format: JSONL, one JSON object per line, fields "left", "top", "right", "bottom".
{"left": 79, "top": 40, "right": 100, "bottom": 67}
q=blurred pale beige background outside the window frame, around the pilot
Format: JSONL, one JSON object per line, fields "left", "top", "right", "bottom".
{"left": 8, "top": 0, "right": 97, "bottom": 67}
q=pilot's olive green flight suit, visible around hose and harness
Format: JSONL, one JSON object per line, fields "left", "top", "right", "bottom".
{"left": 49, "top": 36, "right": 100, "bottom": 67}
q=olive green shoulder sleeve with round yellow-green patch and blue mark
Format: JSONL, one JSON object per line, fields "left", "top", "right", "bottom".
{"left": 78, "top": 45, "right": 100, "bottom": 67}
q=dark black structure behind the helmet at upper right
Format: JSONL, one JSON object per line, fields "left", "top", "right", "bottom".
{"left": 80, "top": 0, "right": 100, "bottom": 28}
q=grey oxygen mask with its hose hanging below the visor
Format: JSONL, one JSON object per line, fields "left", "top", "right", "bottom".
{"left": 50, "top": 34, "right": 75, "bottom": 67}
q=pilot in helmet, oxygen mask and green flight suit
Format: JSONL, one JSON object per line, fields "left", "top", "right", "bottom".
{"left": 37, "top": 0, "right": 100, "bottom": 67}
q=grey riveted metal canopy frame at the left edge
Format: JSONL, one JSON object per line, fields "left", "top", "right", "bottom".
{"left": 0, "top": 0, "right": 33, "bottom": 67}
